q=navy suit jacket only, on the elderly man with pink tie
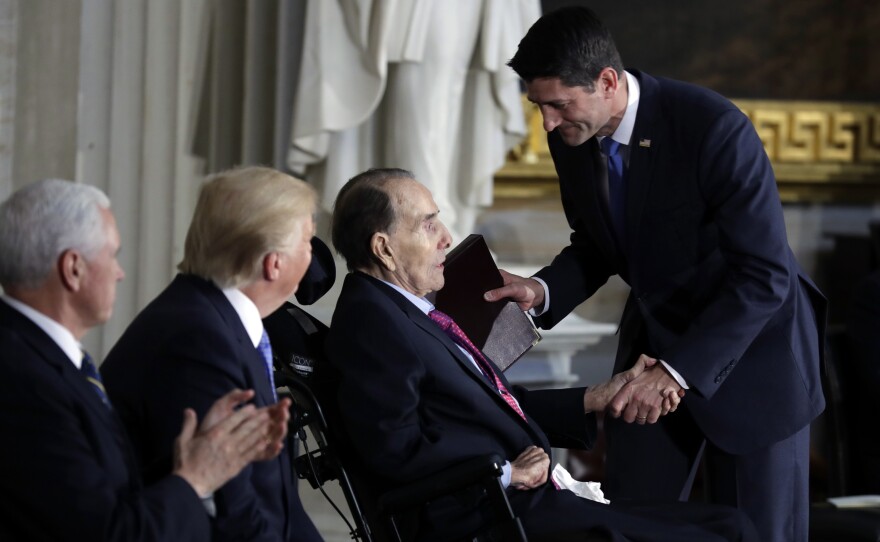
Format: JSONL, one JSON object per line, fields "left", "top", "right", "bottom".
{"left": 327, "top": 272, "right": 595, "bottom": 484}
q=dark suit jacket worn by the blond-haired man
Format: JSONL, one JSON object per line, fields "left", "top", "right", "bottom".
{"left": 101, "top": 275, "right": 320, "bottom": 541}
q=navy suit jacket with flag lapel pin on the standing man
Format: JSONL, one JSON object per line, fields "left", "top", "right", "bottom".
{"left": 537, "top": 71, "right": 825, "bottom": 453}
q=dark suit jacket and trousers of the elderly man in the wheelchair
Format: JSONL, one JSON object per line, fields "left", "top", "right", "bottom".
{"left": 327, "top": 272, "right": 752, "bottom": 540}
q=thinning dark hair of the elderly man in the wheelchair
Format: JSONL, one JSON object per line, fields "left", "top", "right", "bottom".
{"left": 331, "top": 168, "right": 415, "bottom": 271}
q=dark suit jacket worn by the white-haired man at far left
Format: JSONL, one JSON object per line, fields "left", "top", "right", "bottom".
{"left": 0, "top": 302, "right": 210, "bottom": 541}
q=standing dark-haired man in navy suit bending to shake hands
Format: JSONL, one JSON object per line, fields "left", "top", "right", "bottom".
{"left": 487, "top": 7, "right": 825, "bottom": 542}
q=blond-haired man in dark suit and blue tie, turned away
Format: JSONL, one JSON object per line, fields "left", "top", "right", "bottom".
{"left": 102, "top": 167, "right": 321, "bottom": 542}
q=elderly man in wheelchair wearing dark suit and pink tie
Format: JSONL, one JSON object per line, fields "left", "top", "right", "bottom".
{"left": 327, "top": 169, "right": 751, "bottom": 541}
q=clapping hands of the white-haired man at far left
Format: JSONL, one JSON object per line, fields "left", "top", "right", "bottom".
{"left": 168, "top": 390, "right": 290, "bottom": 497}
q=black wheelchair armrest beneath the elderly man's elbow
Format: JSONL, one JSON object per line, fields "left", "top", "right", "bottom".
{"left": 379, "top": 454, "right": 504, "bottom": 515}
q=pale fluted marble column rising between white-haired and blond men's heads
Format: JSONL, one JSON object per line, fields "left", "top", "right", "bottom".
{"left": 75, "top": 0, "right": 207, "bottom": 353}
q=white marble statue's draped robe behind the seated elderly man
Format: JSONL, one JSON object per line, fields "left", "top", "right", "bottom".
{"left": 288, "top": 0, "right": 541, "bottom": 239}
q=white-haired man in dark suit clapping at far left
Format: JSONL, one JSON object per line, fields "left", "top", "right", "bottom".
{"left": 0, "top": 180, "right": 289, "bottom": 542}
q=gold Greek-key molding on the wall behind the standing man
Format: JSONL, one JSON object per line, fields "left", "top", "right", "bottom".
{"left": 495, "top": 98, "right": 880, "bottom": 203}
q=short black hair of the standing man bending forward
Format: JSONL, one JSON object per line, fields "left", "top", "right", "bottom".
{"left": 507, "top": 6, "right": 623, "bottom": 91}
